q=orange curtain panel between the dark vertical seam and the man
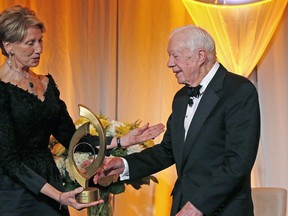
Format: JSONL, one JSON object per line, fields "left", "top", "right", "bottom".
{"left": 114, "top": 0, "right": 191, "bottom": 216}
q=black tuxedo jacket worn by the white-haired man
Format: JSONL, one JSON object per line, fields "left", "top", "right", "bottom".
{"left": 126, "top": 65, "right": 260, "bottom": 216}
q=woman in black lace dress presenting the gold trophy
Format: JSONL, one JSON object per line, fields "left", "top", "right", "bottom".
{"left": 0, "top": 5, "right": 164, "bottom": 216}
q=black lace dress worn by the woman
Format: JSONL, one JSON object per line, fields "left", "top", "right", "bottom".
{"left": 0, "top": 75, "right": 75, "bottom": 216}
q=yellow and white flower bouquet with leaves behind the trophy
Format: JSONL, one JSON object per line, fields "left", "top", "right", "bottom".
{"left": 49, "top": 115, "right": 158, "bottom": 216}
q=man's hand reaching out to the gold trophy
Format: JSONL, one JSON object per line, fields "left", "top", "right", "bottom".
{"left": 93, "top": 157, "right": 125, "bottom": 186}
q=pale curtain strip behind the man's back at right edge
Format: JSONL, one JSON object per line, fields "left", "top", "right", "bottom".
{"left": 257, "top": 3, "right": 288, "bottom": 201}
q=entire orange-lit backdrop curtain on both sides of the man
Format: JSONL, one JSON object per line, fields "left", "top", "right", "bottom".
{"left": 0, "top": 0, "right": 288, "bottom": 216}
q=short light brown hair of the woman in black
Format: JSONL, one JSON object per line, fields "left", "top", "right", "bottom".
{"left": 0, "top": 5, "right": 45, "bottom": 56}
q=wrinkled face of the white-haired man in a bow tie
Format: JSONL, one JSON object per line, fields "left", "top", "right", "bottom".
{"left": 167, "top": 34, "right": 200, "bottom": 84}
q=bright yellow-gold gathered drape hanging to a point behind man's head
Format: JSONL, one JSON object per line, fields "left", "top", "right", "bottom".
{"left": 182, "top": 0, "right": 287, "bottom": 77}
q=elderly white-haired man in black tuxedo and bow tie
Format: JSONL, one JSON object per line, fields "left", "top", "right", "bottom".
{"left": 94, "top": 25, "right": 260, "bottom": 216}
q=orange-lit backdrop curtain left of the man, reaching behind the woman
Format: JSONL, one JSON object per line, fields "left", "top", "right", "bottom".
{"left": 0, "top": 0, "right": 192, "bottom": 216}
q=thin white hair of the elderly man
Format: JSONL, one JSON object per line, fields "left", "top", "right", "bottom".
{"left": 170, "top": 25, "right": 216, "bottom": 60}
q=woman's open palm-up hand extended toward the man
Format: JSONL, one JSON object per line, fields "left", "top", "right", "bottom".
{"left": 121, "top": 123, "right": 165, "bottom": 147}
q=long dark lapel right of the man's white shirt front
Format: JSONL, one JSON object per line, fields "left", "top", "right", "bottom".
{"left": 182, "top": 65, "right": 226, "bottom": 167}
